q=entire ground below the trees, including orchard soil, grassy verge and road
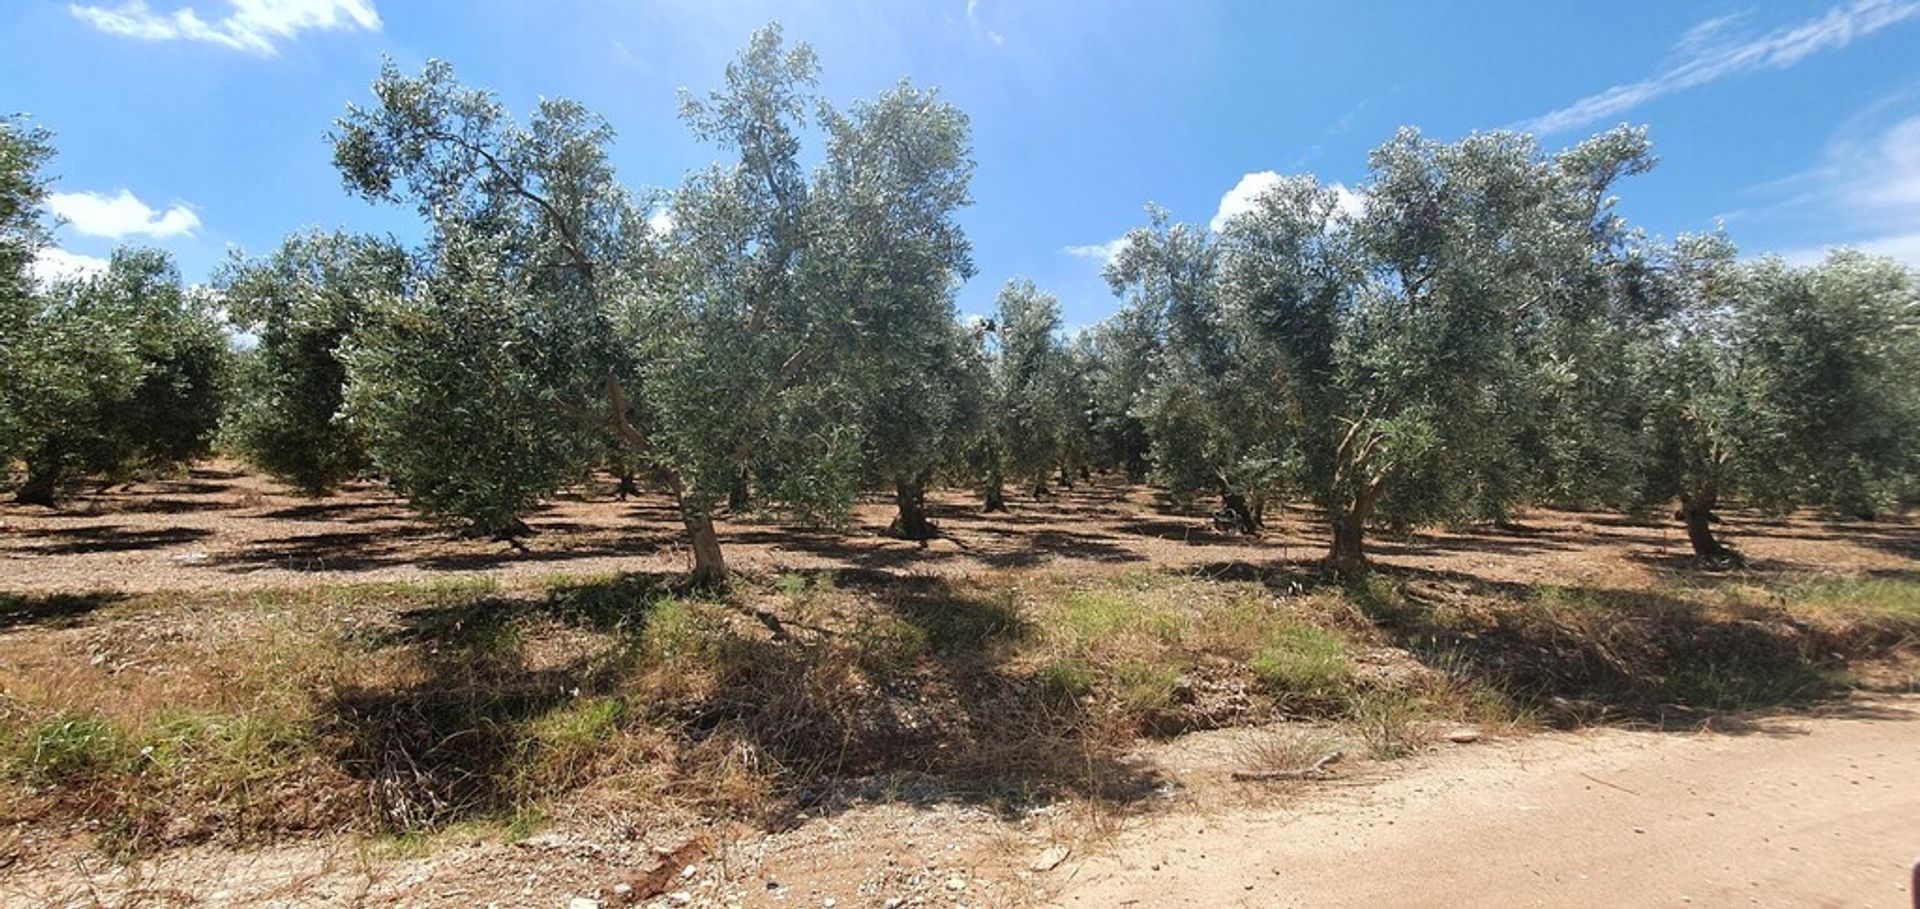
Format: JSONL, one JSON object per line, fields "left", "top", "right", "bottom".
{"left": 0, "top": 461, "right": 1920, "bottom": 907}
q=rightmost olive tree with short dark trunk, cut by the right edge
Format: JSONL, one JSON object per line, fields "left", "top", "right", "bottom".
{"left": 1636, "top": 234, "right": 1920, "bottom": 563}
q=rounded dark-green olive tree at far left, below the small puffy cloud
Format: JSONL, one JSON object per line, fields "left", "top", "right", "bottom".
{"left": 4, "top": 248, "right": 232, "bottom": 505}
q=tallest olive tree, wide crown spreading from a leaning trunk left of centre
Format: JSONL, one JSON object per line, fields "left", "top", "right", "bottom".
{"left": 334, "top": 27, "right": 966, "bottom": 582}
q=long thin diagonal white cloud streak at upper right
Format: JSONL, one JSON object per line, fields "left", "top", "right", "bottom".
{"left": 1521, "top": 0, "right": 1920, "bottom": 135}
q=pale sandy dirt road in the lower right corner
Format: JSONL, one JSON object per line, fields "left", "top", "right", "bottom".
{"left": 1052, "top": 696, "right": 1920, "bottom": 909}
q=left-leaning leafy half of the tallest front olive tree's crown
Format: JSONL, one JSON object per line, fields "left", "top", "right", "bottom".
{"left": 332, "top": 61, "right": 633, "bottom": 534}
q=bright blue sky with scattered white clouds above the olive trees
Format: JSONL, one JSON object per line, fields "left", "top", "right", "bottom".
{"left": 0, "top": 0, "right": 1920, "bottom": 325}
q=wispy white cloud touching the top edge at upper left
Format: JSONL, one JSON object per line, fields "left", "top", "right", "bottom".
{"left": 67, "top": 0, "right": 380, "bottom": 56}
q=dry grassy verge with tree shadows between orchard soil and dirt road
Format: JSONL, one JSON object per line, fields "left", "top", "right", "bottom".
{"left": 0, "top": 573, "right": 1920, "bottom": 849}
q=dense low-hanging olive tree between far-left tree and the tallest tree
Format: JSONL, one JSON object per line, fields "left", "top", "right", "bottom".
{"left": 217, "top": 231, "right": 411, "bottom": 496}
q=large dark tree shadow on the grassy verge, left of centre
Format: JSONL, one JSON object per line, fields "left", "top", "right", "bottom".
{"left": 321, "top": 571, "right": 1164, "bottom": 830}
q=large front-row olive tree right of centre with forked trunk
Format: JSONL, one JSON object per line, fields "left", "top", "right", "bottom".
{"left": 1223, "top": 129, "right": 1651, "bottom": 571}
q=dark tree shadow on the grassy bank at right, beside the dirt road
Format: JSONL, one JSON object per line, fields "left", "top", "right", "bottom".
{"left": 1348, "top": 567, "right": 1920, "bottom": 732}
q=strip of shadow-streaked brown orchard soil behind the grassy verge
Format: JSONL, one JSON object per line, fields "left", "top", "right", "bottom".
{"left": 0, "top": 463, "right": 1920, "bottom": 592}
